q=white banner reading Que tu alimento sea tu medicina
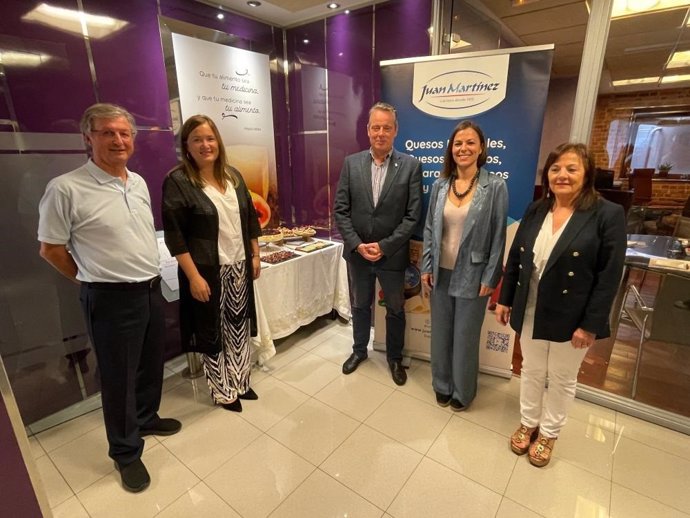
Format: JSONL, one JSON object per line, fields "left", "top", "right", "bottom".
{"left": 170, "top": 33, "right": 279, "bottom": 227}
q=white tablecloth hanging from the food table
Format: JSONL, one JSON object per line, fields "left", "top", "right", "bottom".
{"left": 252, "top": 242, "right": 351, "bottom": 365}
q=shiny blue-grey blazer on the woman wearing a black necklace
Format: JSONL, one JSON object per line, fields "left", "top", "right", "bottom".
{"left": 422, "top": 169, "right": 508, "bottom": 298}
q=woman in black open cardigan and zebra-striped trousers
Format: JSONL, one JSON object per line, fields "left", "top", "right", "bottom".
{"left": 163, "top": 115, "right": 261, "bottom": 412}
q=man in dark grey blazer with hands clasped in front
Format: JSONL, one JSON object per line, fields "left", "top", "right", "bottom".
{"left": 335, "top": 102, "right": 422, "bottom": 385}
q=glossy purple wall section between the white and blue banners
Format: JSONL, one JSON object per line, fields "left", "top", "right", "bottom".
{"left": 280, "top": 0, "right": 431, "bottom": 233}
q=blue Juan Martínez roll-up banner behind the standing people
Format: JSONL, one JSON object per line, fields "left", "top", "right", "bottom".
{"left": 374, "top": 45, "right": 553, "bottom": 377}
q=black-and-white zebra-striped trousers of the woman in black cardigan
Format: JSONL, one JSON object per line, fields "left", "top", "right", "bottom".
{"left": 201, "top": 261, "right": 251, "bottom": 404}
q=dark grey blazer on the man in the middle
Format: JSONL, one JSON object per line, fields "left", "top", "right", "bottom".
{"left": 334, "top": 149, "right": 422, "bottom": 270}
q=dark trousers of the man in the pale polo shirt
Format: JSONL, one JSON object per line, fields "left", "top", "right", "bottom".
{"left": 80, "top": 279, "right": 165, "bottom": 465}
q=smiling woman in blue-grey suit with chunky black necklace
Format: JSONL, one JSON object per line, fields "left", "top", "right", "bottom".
{"left": 422, "top": 121, "right": 508, "bottom": 412}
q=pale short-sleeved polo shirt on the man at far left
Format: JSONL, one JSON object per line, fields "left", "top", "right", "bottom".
{"left": 38, "top": 160, "right": 159, "bottom": 282}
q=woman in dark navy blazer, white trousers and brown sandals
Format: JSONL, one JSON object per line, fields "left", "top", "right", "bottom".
{"left": 496, "top": 144, "right": 626, "bottom": 467}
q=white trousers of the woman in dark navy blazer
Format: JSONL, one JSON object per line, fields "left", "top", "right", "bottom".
{"left": 520, "top": 303, "right": 587, "bottom": 437}
